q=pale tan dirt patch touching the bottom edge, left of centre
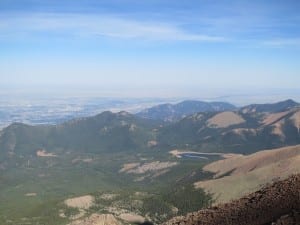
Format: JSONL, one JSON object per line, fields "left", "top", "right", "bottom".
{"left": 69, "top": 214, "right": 122, "bottom": 225}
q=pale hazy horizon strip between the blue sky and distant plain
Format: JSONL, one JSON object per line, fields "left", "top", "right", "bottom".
{"left": 0, "top": 86, "right": 300, "bottom": 106}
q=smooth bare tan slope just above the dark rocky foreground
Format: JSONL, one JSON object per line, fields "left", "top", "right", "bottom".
{"left": 195, "top": 145, "right": 300, "bottom": 202}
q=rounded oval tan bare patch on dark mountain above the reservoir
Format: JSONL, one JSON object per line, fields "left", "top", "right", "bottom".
{"left": 207, "top": 112, "right": 245, "bottom": 128}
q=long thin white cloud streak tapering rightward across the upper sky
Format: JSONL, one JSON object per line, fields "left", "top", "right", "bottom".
{"left": 0, "top": 14, "right": 225, "bottom": 42}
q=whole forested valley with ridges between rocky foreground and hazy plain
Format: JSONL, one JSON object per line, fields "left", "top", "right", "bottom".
{"left": 0, "top": 100, "right": 300, "bottom": 225}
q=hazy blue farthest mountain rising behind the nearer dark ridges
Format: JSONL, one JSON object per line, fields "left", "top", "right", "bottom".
{"left": 136, "top": 100, "right": 236, "bottom": 122}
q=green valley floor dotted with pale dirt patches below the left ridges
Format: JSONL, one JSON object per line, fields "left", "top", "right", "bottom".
{"left": 0, "top": 149, "right": 210, "bottom": 225}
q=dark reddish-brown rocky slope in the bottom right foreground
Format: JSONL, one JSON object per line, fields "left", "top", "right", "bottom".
{"left": 163, "top": 174, "right": 300, "bottom": 225}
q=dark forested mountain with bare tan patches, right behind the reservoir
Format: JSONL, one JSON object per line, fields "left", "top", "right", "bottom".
{"left": 158, "top": 103, "right": 300, "bottom": 154}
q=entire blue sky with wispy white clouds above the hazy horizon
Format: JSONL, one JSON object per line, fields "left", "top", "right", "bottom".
{"left": 0, "top": 0, "right": 300, "bottom": 97}
